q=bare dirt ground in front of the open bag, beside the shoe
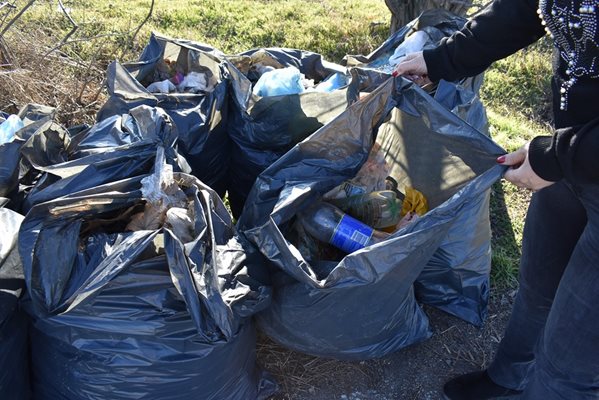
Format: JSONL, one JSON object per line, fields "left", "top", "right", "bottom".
{"left": 258, "top": 289, "right": 516, "bottom": 400}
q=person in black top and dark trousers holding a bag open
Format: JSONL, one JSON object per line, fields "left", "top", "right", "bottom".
{"left": 394, "top": 0, "right": 599, "bottom": 400}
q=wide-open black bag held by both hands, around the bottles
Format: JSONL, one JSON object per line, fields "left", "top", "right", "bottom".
{"left": 238, "top": 78, "right": 504, "bottom": 359}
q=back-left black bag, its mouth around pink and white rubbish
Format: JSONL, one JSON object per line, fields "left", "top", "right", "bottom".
{"left": 97, "top": 34, "right": 230, "bottom": 196}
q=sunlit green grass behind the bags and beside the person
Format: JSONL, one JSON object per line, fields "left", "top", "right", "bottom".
{"left": 7, "top": 0, "right": 550, "bottom": 285}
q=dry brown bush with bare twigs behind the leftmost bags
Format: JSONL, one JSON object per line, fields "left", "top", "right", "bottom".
{"left": 0, "top": 0, "right": 154, "bottom": 126}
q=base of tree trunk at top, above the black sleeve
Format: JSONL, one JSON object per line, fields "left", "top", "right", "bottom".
{"left": 385, "top": 0, "right": 473, "bottom": 33}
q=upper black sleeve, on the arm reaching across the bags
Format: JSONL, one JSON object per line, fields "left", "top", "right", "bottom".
{"left": 423, "top": 0, "right": 545, "bottom": 81}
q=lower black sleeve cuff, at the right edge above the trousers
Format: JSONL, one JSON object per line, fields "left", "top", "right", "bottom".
{"left": 528, "top": 118, "right": 599, "bottom": 183}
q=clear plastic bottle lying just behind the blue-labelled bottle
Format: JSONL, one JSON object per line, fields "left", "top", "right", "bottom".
{"left": 331, "top": 190, "right": 402, "bottom": 228}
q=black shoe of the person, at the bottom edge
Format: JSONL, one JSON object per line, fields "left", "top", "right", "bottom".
{"left": 443, "top": 370, "right": 522, "bottom": 400}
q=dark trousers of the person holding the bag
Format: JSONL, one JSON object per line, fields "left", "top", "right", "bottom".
{"left": 488, "top": 181, "right": 599, "bottom": 400}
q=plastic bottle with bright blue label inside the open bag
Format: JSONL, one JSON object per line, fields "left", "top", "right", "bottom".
{"left": 299, "top": 202, "right": 389, "bottom": 253}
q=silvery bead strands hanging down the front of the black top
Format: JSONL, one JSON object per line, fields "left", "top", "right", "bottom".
{"left": 537, "top": 0, "right": 599, "bottom": 110}
